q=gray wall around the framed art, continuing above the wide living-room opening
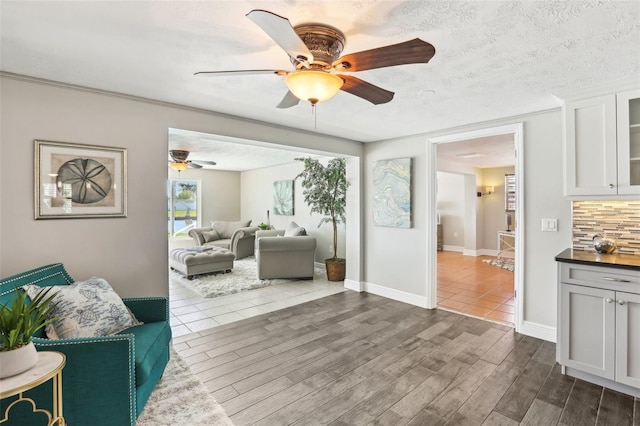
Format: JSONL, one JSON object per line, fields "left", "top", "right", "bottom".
{"left": 0, "top": 75, "right": 362, "bottom": 296}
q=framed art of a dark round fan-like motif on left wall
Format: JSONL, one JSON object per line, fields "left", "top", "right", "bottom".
{"left": 34, "top": 140, "right": 127, "bottom": 219}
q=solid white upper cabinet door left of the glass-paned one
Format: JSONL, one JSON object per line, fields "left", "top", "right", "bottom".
{"left": 564, "top": 95, "right": 618, "bottom": 195}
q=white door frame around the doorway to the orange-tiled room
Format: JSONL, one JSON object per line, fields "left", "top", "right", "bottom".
{"left": 426, "top": 122, "right": 525, "bottom": 332}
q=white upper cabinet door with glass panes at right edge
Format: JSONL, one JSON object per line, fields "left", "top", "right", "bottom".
{"left": 616, "top": 90, "right": 640, "bottom": 194}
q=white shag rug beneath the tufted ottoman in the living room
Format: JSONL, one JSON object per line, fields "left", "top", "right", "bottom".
{"left": 169, "top": 256, "right": 326, "bottom": 298}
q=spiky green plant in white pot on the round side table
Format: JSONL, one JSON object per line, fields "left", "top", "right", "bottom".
{"left": 0, "top": 288, "right": 55, "bottom": 378}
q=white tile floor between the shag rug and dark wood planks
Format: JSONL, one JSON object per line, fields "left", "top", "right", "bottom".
{"left": 169, "top": 268, "right": 344, "bottom": 337}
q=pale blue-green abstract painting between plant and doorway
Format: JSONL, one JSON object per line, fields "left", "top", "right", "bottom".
{"left": 373, "top": 158, "right": 411, "bottom": 228}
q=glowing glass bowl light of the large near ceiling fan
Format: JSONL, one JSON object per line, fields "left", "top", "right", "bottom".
{"left": 285, "top": 70, "right": 344, "bottom": 104}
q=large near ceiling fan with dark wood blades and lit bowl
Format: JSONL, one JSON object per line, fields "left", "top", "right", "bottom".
{"left": 195, "top": 9, "right": 436, "bottom": 108}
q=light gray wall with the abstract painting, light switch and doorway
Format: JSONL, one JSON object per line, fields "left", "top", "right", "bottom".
{"left": 364, "top": 109, "right": 571, "bottom": 336}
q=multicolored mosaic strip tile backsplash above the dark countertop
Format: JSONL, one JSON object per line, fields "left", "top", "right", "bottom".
{"left": 573, "top": 200, "right": 640, "bottom": 255}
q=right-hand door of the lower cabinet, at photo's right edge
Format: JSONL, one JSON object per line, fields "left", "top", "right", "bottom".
{"left": 616, "top": 292, "right": 640, "bottom": 388}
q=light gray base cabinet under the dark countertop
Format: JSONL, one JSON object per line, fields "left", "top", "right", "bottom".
{"left": 557, "top": 263, "right": 640, "bottom": 396}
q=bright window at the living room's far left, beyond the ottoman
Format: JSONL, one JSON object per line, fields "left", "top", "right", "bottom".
{"left": 167, "top": 179, "right": 200, "bottom": 237}
